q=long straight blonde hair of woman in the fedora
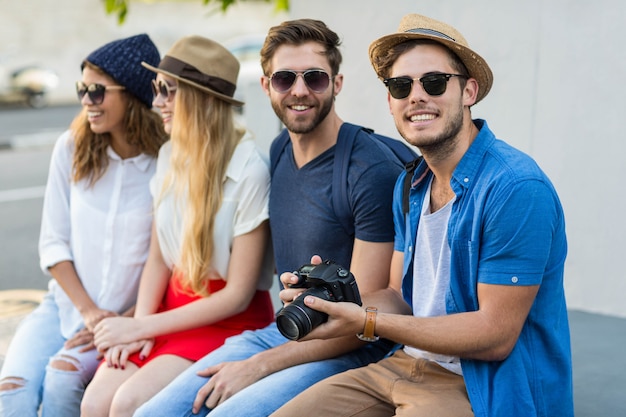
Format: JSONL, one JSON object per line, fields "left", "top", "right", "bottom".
{"left": 160, "top": 82, "right": 243, "bottom": 296}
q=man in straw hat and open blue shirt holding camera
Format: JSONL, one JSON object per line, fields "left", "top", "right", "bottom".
{"left": 272, "top": 14, "right": 574, "bottom": 417}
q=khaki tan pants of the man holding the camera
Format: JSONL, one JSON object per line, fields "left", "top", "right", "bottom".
{"left": 272, "top": 350, "right": 474, "bottom": 417}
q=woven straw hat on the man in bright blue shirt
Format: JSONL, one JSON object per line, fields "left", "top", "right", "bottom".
{"left": 369, "top": 14, "right": 493, "bottom": 103}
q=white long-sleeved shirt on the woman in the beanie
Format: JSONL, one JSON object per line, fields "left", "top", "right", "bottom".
{"left": 39, "top": 131, "right": 156, "bottom": 338}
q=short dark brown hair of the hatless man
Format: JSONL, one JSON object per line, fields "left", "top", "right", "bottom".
{"left": 261, "top": 19, "right": 341, "bottom": 75}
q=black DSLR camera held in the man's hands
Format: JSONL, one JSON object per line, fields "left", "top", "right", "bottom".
{"left": 276, "top": 261, "right": 361, "bottom": 340}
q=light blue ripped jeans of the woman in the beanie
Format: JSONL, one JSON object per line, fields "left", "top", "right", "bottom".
{"left": 0, "top": 293, "right": 100, "bottom": 417}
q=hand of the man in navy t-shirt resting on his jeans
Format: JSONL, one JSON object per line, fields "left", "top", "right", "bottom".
{"left": 193, "top": 360, "right": 265, "bottom": 414}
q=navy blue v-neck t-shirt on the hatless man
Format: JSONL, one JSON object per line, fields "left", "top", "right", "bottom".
{"left": 269, "top": 125, "right": 402, "bottom": 275}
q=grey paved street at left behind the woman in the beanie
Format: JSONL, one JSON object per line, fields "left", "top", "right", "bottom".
{"left": 0, "top": 106, "right": 78, "bottom": 290}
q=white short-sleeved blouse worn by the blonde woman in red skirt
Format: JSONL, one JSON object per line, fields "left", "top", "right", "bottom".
{"left": 150, "top": 133, "right": 274, "bottom": 290}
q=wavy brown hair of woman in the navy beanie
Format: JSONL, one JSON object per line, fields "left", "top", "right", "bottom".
{"left": 70, "top": 62, "right": 167, "bottom": 185}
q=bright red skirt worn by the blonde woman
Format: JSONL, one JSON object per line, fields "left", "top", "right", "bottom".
{"left": 128, "top": 274, "right": 274, "bottom": 367}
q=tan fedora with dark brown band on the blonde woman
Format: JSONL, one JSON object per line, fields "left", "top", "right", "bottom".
{"left": 141, "top": 36, "right": 244, "bottom": 106}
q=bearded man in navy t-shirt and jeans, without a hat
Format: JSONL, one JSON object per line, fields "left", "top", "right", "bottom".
{"left": 135, "top": 19, "right": 402, "bottom": 417}
